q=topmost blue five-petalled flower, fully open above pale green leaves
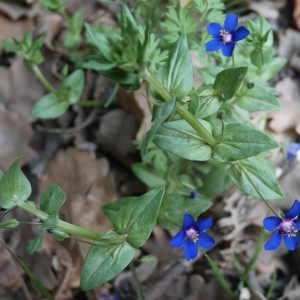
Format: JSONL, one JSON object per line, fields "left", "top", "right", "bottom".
{"left": 206, "top": 14, "right": 250, "bottom": 57}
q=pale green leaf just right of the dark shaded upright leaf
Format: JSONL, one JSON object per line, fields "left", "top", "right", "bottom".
{"left": 235, "top": 86, "right": 282, "bottom": 111}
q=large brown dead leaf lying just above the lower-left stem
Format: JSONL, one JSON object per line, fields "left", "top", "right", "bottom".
{"left": 39, "top": 148, "right": 116, "bottom": 257}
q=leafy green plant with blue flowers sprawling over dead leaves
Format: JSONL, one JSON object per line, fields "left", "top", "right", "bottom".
{"left": 0, "top": 0, "right": 292, "bottom": 299}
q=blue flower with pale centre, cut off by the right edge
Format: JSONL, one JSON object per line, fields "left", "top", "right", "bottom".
{"left": 263, "top": 200, "right": 300, "bottom": 250}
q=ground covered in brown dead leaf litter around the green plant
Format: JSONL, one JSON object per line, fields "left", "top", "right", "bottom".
{"left": 0, "top": 0, "right": 300, "bottom": 300}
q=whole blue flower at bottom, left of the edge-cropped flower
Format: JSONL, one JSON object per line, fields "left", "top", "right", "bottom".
{"left": 170, "top": 214, "right": 215, "bottom": 261}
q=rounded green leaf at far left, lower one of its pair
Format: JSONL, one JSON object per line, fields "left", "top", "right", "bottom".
{"left": 32, "top": 94, "right": 69, "bottom": 119}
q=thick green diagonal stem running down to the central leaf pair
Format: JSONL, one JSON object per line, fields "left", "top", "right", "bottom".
{"left": 144, "top": 73, "right": 216, "bottom": 147}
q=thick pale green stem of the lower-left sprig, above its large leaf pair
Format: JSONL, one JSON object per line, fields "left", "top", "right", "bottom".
{"left": 17, "top": 202, "right": 103, "bottom": 241}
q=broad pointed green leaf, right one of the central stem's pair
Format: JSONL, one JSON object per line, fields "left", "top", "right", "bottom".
{"left": 213, "top": 123, "right": 279, "bottom": 162}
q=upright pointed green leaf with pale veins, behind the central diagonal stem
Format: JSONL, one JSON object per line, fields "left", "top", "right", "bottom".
{"left": 156, "top": 35, "right": 193, "bottom": 100}
